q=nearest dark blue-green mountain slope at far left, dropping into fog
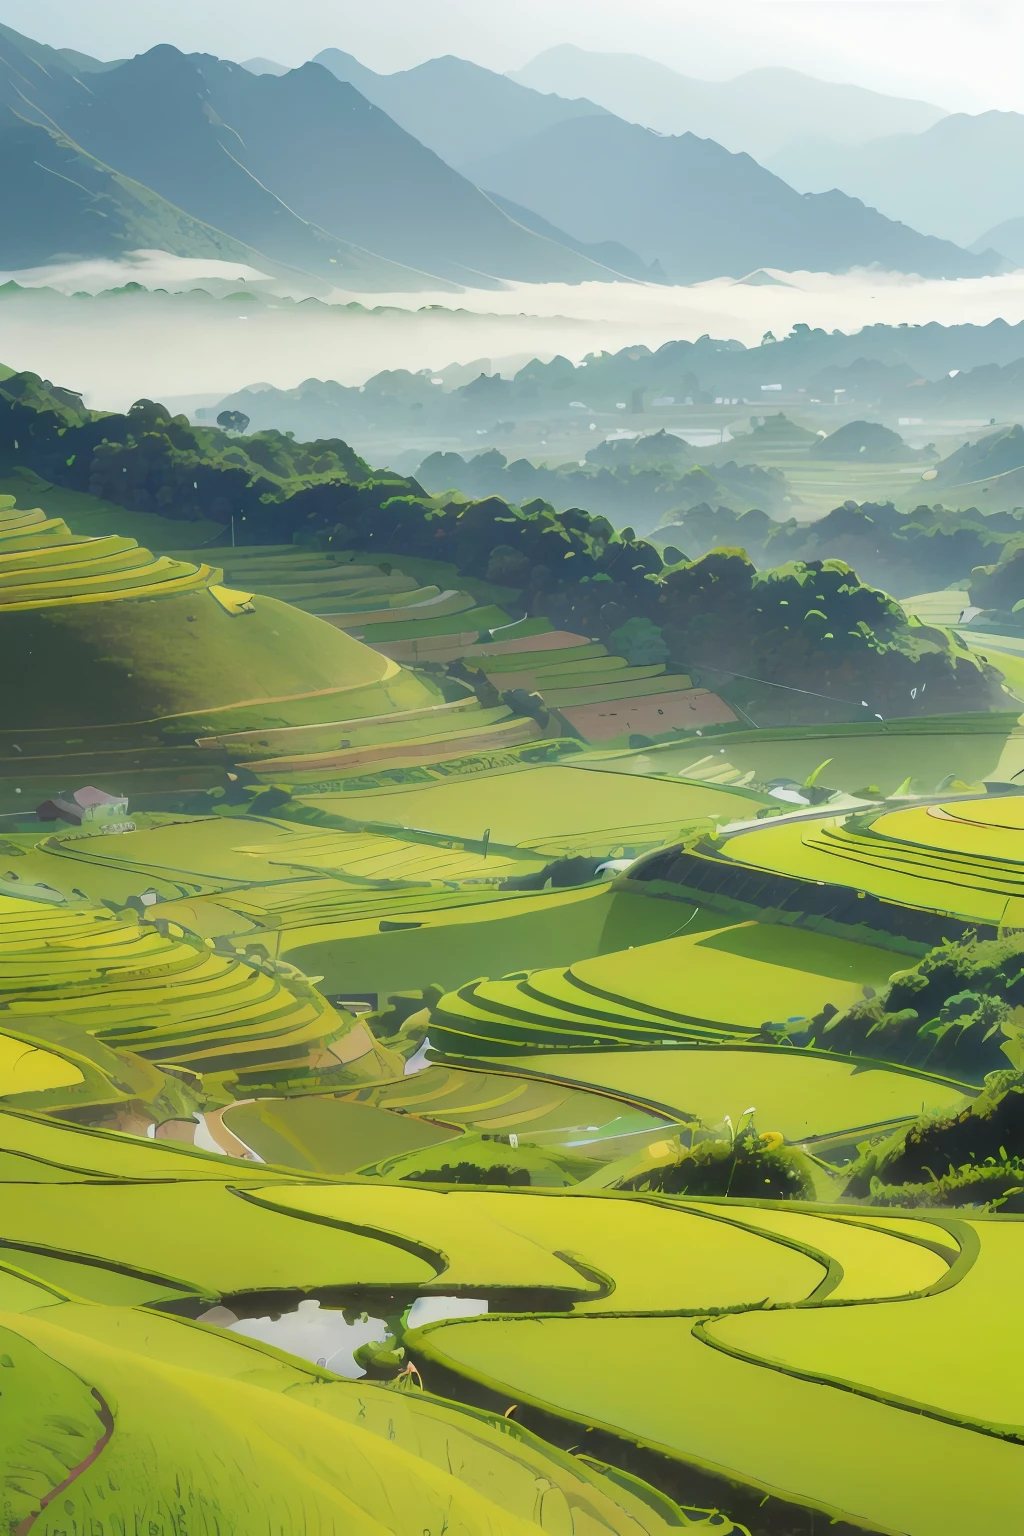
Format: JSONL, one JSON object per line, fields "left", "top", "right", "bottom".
{"left": 0, "top": 123, "right": 271, "bottom": 270}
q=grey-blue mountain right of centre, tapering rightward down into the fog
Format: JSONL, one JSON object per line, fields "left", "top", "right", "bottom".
{"left": 470, "top": 117, "right": 1001, "bottom": 283}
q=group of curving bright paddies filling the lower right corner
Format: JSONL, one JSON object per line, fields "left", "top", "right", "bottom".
{"left": 410, "top": 1204, "right": 1022, "bottom": 1536}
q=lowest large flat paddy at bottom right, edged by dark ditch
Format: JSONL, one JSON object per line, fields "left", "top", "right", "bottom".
{"left": 410, "top": 1296, "right": 1024, "bottom": 1536}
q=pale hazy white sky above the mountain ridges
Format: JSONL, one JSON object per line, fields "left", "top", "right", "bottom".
{"left": 0, "top": 0, "right": 1024, "bottom": 112}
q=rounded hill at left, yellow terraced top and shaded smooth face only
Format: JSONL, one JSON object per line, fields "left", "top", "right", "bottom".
{"left": 0, "top": 507, "right": 436, "bottom": 730}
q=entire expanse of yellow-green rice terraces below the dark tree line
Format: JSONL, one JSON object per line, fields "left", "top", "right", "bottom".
{"left": 10, "top": 507, "right": 1024, "bottom": 1536}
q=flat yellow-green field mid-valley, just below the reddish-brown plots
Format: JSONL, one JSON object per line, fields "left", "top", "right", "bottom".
{"left": 302, "top": 765, "right": 773, "bottom": 852}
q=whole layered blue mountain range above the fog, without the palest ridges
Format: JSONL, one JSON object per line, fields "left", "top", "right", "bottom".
{"left": 0, "top": 29, "right": 999, "bottom": 292}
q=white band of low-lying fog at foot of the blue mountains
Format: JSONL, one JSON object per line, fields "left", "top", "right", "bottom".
{"left": 0, "top": 252, "right": 1024, "bottom": 409}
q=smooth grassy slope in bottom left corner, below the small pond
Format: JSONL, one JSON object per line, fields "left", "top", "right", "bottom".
{"left": 3, "top": 1303, "right": 696, "bottom": 1536}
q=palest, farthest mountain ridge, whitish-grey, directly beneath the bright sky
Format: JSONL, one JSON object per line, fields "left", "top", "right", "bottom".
{"left": 511, "top": 45, "right": 946, "bottom": 160}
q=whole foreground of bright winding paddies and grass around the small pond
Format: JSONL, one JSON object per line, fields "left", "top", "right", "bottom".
{"left": 0, "top": 1111, "right": 1024, "bottom": 1536}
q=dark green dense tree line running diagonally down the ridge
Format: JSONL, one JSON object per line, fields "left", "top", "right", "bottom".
{"left": 0, "top": 375, "right": 1006, "bottom": 723}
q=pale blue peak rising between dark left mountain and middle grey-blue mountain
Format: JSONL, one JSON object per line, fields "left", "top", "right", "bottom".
{"left": 313, "top": 48, "right": 605, "bottom": 170}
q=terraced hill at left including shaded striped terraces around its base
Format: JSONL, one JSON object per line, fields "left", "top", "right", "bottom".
{"left": 0, "top": 498, "right": 540, "bottom": 808}
